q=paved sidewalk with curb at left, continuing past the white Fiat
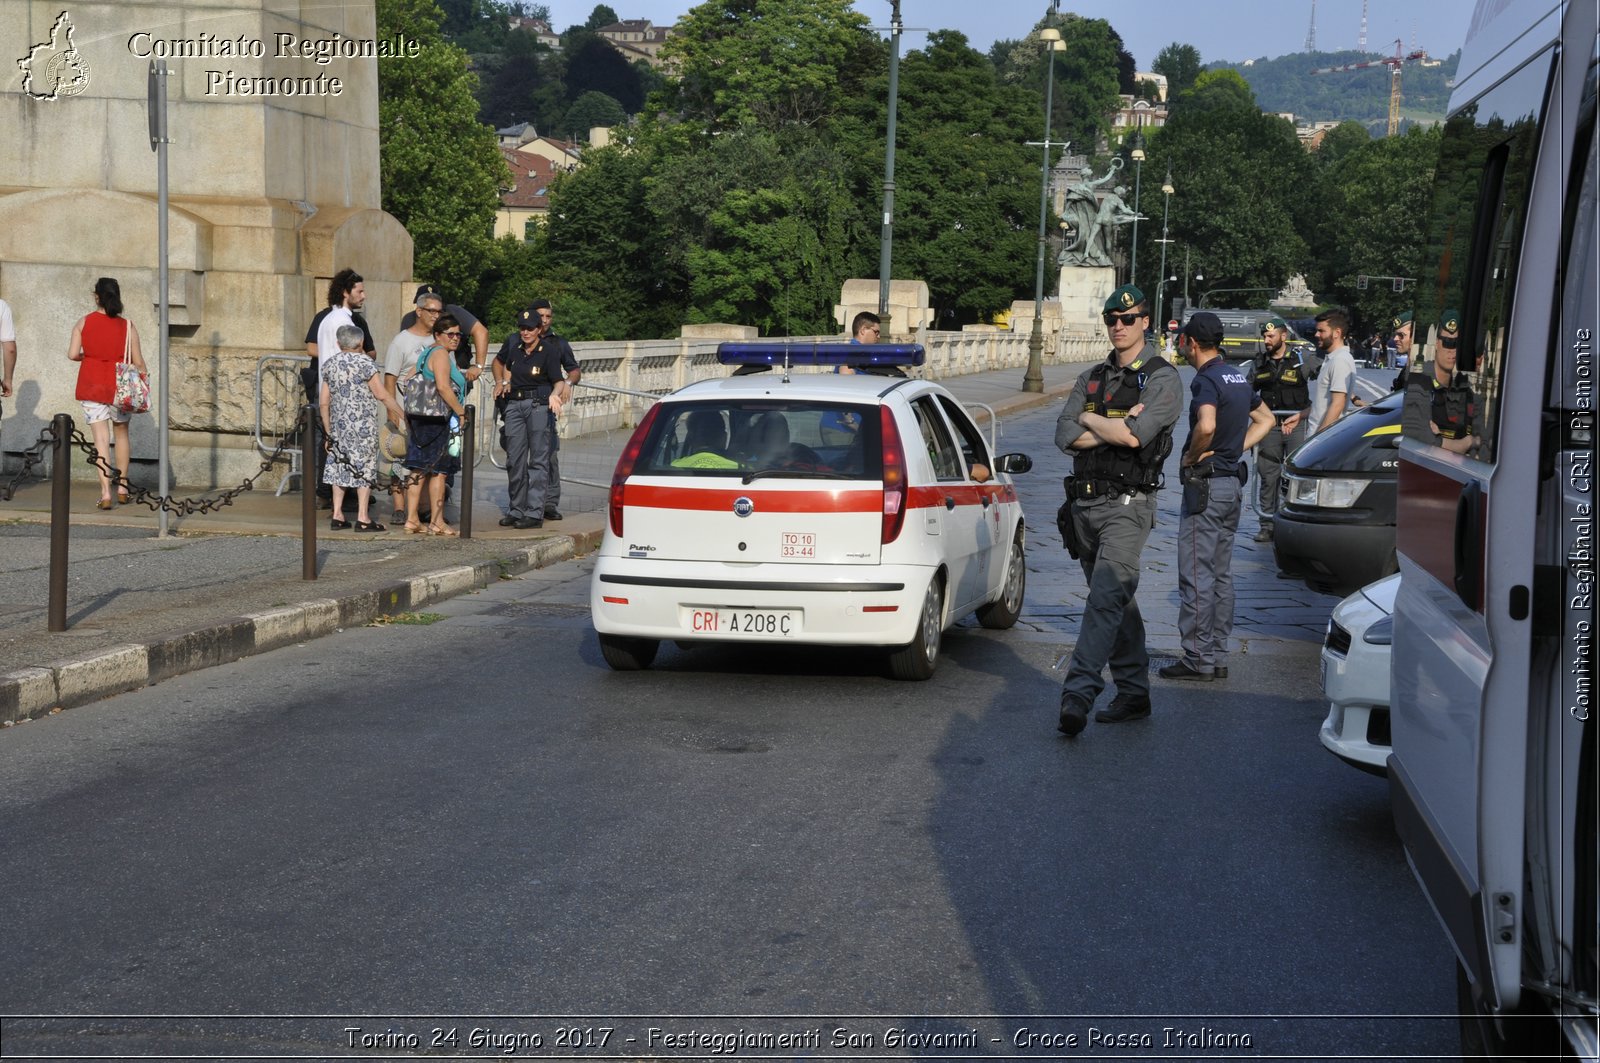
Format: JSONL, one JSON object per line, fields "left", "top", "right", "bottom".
{"left": 0, "top": 365, "right": 1083, "bottom": 727}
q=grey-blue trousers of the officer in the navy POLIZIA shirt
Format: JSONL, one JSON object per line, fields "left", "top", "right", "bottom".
{"left": 1178, "top": 475, "right": 1243, "bottom": 672}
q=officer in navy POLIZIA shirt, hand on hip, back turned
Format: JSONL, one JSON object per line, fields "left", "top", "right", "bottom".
{"left": 1157, "top": 311, "right": 1282, "bottom": 682}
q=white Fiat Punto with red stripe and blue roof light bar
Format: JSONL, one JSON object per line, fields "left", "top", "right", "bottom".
{"left": 589, "top": 343, "right": 1032, "bottom": 679}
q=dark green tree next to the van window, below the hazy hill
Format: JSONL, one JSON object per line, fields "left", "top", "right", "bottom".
{"left": 1312, "top": 126, "right": 1443, "bottom": 327}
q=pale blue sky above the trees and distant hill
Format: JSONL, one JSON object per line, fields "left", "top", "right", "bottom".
{"left": 549, "top": 0, "right": 1472, "bottom": 69}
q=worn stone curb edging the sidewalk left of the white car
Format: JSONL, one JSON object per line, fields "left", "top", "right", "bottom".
{"left": 0, "top": 532, "right": 602, "bottom": 727}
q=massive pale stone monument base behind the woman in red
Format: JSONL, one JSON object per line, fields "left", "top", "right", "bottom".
{"left": 0, "top": 0, "right": 411, "bottom": 485}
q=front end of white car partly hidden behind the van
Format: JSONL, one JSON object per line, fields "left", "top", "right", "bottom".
{"left": 1320, "top": 573, "right": 1400, "bottom": 775}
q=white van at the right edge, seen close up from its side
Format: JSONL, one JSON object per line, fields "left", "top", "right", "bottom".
{"left": 1389, "top": 0, "right": 1600, "bottom": 1060}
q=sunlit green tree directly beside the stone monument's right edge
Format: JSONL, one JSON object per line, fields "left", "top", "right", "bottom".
{"left": 378, "top": 0, "right": 509, "bottom": 303}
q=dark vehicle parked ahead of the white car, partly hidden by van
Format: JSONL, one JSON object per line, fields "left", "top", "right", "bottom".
{"left": 1272, "top": 392, "right": 1405, "bottom": 596}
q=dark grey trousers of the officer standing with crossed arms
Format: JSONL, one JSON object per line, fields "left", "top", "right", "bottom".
{"left": 1061, "top": 495, "right": 1155, "bottom": 704}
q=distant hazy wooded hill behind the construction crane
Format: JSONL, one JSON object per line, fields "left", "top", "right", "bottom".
{"left": 1214, "top": 50, "right": 1461, "bottom": 133}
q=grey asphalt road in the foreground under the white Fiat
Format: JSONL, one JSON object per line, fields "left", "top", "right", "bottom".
{"left": 0, "top": 397, "right": 1454, "bottom": 1058}
